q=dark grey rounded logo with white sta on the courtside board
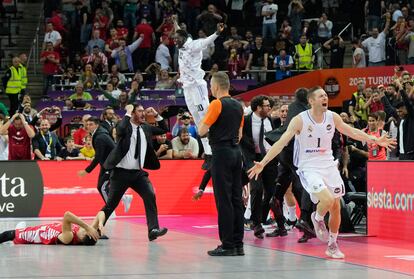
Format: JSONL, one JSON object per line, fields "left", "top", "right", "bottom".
{"left": 0, "top": 161, "right": 43, "bottom": 217}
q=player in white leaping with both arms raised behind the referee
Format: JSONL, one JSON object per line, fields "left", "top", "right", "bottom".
{"left": 174, "top": 19, "right": 224, "bottom": 170}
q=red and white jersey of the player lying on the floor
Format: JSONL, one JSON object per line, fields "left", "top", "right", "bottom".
{"left": 13, "top": 223, "right": 79, "bottom": 245}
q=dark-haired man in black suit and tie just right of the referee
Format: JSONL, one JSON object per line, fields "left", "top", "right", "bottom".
{"left": 240, "top": 95, "right": 287, "bottom": 239}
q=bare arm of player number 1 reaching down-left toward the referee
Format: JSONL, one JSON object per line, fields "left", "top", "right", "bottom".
{"left": 247, "top": 116, "right": 303, "bottom": 179}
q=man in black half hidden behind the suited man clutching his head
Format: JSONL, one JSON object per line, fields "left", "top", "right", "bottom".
{"left": 78, "top": 116, "right": 115, "bottom": 203}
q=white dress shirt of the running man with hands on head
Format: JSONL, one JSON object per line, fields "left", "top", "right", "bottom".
{"left": 116, "top": 122, "right": 147, "bottom": 170}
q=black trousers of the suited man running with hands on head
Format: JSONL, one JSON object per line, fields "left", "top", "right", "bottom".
{"left": 101, "top": 168, "right": 159, "bottom": 231}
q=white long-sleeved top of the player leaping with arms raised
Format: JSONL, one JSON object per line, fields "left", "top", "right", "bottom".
{"left": 178, "top": 33, "right": 218, "bottom": 88}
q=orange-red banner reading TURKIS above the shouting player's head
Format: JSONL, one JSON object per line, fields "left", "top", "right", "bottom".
{"left": 239, "top": 65, "right": 414, "bottom": 107}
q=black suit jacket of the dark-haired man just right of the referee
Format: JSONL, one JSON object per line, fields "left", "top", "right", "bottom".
{"left": 240, "top": 113, "right": 277, "bottom": 168}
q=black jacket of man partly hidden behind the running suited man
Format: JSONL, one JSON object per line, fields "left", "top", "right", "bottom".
{"left": 85, "top": 125, "right": 115, "bottom": 173}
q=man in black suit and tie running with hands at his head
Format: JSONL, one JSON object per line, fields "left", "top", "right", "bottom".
{"left": 101, "top": 105, "right": 168, "bottom": 241}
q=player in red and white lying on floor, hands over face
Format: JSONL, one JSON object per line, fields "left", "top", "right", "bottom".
{"left": 0, "top": 211, "right": 105, "bottom": 246}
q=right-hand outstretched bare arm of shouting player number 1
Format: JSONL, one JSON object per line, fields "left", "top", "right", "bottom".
{"left": 334, "top": 113, "right": 397, "bottom": 150}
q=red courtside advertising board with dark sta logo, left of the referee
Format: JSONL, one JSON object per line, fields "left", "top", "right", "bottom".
{"left": 0, "top": 160, "right": 216, "bottom": 217}
